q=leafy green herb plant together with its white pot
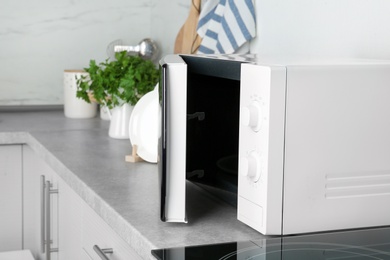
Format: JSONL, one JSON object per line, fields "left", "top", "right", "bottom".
{"left": 77, "top": 51, "right": 159, "bottom": 139}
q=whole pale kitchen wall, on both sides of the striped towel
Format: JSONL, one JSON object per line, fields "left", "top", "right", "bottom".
{"left": 0, "top": 0, "right": 390, "bottom": 106}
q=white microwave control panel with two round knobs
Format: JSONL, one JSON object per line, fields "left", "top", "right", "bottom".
{"left": 238, "top": 64, "right": 286, "bottom": 234}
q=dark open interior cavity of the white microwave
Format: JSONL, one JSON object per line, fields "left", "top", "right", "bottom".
{"left": 182, "top": 56, "right": 241, "bottom": 206}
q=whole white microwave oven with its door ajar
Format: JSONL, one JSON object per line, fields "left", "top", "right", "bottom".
{"left": 158, "top": 55, "right": 390, "bottom": 235}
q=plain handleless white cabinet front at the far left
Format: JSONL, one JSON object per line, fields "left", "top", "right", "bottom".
{"left": 0, "top": 145, "right": 22, "bottom": 252}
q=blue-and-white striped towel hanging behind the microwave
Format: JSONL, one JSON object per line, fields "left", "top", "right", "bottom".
{"left": 197, "top": 0, "right": 256, "bottom": 54}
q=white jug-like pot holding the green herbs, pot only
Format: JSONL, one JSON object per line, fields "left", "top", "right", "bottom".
{"left": 108, "top": 104, "right": 133, "bottom": 139}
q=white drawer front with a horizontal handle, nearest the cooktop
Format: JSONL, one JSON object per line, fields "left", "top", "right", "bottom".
{"left": 83, "top": 205, "right": 141, "bottom": 260}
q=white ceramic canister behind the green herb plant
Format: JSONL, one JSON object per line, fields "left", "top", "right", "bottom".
{"left": 64, "top": 70, "right": 97, "bottom": 118}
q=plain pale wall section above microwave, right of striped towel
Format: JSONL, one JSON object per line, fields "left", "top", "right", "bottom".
{"left": 251, "top": 0, "right": 390, "bottom": 59}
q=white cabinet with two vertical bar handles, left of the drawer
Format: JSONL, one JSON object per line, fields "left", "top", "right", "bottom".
{"left": 23, "top": 146, "right": 85, "bottom": 260}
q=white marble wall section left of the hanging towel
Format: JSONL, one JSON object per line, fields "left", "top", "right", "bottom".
{"left": 0, "top": 0, "right": 190, "bottom": 106}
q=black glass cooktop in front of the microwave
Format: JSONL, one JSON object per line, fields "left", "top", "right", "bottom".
{"left": 152, "top": 227, "right": 390, "bottom": 260}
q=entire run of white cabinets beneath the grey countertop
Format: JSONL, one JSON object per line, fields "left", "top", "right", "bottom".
{"left": 0, "top": 145, "right": 141, "bottom": 260}
